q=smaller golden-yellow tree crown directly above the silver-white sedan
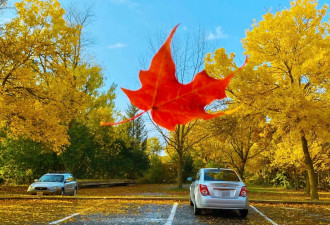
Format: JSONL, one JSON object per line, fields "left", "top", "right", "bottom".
{"left": 189, "top": 105, "right": 272, "bottom": 179}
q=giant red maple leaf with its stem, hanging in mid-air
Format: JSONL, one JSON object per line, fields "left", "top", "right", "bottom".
{"left": 101, "top": 25, "right": 247, "bottom": 131}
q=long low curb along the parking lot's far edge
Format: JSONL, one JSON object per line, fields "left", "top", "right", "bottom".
{"left": 0, "top": 196, "right": 330, "bottom": 205}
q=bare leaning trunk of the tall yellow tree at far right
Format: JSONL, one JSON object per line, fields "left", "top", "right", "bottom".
{"left": 301, "top": 135, "right": 319, "bottom": 200}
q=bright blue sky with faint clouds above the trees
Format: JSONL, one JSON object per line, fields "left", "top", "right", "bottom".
{"left": 1, "top": 0, "right": 328, "bottom": 135}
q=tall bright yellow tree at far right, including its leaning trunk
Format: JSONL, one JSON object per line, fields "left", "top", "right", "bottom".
{"left": 242, "top": 0, "right": 330, "bottom": 199}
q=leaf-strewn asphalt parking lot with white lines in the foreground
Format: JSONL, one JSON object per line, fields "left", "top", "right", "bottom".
{"left": 0, "top": 199, "right": 330, "bottom": 225}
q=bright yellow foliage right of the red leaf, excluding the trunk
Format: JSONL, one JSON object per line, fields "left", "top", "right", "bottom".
{"left": 205, "top": 0, "right": 330, "bottom": 182}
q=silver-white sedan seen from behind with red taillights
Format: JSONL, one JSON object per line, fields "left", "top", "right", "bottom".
{"left": 188, "top": 168, "right": 249, "bottom": 217}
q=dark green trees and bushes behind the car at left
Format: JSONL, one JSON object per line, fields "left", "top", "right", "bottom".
{"left": 0, "top": 104, "right": 149, "bottom": 184}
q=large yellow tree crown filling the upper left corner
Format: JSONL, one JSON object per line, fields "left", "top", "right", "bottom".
{"left": 0, "top": 0, "right": 102, "bottom": 151}
